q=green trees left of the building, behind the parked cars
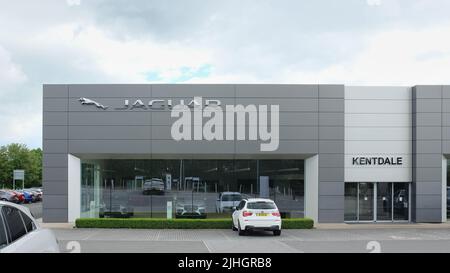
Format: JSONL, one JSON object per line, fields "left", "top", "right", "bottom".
{"left": 0, "top": 143, "right": 42, "bottom": 188}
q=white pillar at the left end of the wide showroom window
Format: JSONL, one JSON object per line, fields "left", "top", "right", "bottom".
{"left": 67, "top": 154, "right": 81, "bottom": 222}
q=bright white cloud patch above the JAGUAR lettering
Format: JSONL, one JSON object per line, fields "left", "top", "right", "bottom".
{"left": 33, "top": 24, "right": 211, "bottom": 83}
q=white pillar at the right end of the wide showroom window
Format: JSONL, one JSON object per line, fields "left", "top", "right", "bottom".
{"left": 304, "top": 155, "right": 319, "bottom": 223}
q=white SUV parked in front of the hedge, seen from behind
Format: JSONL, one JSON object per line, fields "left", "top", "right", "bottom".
{"left": 232, "top": 198, "right": 281, "bottom": 236}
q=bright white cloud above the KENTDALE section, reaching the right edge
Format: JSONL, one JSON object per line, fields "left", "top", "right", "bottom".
{"left": 282, "top": 26, "right": 450, "bottom": 85}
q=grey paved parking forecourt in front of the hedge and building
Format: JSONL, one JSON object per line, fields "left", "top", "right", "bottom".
{"left": 53, "top": 228, "right": 450, "bottom": 253}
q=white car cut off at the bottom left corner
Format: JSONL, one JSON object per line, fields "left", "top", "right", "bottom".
{"left": 0, "top": 201, "right": 59, "bottom": 253}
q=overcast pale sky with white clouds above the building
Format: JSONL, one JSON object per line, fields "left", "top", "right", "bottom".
{"left": 0, "top": 0, "right": 450, "bottom": 148}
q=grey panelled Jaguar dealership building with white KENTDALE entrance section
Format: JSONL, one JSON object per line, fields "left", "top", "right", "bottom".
{"left": 43, "top": 84, "right": 450, "bottom": 223}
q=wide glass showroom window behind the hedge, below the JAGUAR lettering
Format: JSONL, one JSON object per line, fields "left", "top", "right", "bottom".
{"left": 81, "top": 159, "right": 304, "bottom": 218}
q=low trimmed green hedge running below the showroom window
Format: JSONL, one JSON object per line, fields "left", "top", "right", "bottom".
{"left": 75, "top": 218, "right": 314, "bottom": 229}
